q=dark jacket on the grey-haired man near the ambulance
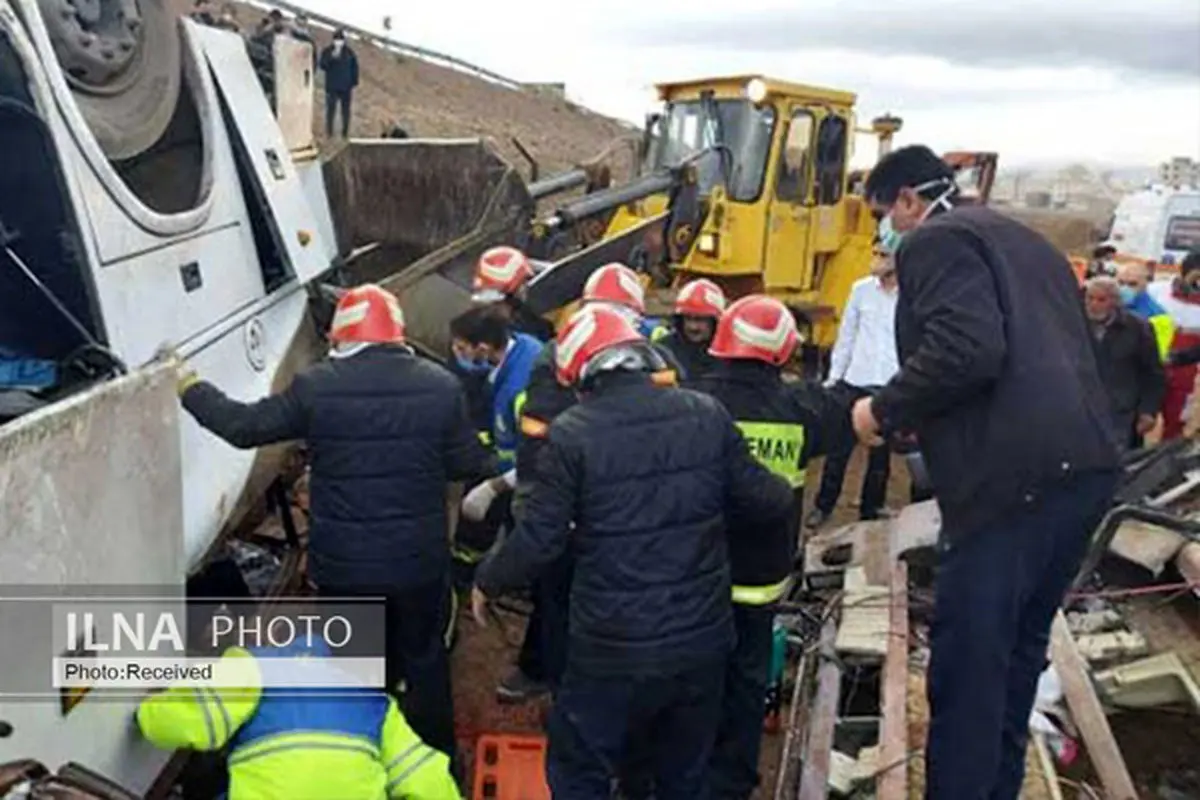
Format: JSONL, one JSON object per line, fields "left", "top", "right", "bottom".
{"left": 1093, "top": 308, "right": 1166, "bottom": 441}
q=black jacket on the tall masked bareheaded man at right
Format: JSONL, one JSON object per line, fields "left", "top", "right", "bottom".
{"left": 872, "top": 206, "right": 1116, "bottom": 534}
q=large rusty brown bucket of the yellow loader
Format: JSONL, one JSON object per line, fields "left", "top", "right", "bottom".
{"left": 324, "top": 139, "right": 534, "bottom": 355}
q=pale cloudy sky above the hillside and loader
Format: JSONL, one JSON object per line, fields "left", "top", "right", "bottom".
{"left": 294, "top": 0, "right": 1200, "bottom": 166}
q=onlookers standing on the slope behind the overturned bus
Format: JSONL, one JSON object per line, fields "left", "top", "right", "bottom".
{"left": 191, "top": 0, "right": 360, "bottom": 139}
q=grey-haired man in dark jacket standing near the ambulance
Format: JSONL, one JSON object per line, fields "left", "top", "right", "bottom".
{"left": 1084, "top": 276, "right": 1166, "bottom": 449}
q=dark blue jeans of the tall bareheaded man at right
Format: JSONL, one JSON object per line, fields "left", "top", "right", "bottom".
{"left": 925, "top": 473, "right": 1116, "bottom": 800}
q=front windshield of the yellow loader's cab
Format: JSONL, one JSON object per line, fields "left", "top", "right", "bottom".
{"left": 646, "top": 100, "right": 775, "bottom": 203}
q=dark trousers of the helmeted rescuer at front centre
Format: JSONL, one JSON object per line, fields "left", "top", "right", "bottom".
{"left": 546, "top": 660, "right": 725, "bottom": 800}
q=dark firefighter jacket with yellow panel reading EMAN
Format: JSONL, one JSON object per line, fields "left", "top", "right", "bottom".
{"left": 690, "top": 361, "right": 853, "bottom": 606}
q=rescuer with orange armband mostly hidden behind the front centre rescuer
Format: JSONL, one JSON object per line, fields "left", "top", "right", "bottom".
{"left": 496, "top": 263, "right": 679, "bottom": 703}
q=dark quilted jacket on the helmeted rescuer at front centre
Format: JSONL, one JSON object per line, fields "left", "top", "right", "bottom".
{"left": 476, "top": 372, "right": 792, "bottom": 678}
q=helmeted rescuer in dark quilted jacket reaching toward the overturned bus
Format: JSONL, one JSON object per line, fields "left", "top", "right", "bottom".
{"left": 169, "top": 284, "right": 496, "bottom": 756}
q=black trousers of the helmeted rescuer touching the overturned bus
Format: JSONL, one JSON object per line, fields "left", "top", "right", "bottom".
{"left": 320, "top": 577, "right": 455, "bottom": 759}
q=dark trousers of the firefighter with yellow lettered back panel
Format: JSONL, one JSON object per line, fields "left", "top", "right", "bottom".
{"left": 710, "top": 603, "right": 775, "bottom": 800}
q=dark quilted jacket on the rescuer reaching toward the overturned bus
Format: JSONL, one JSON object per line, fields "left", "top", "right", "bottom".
{"left": 182, "top": 347, "right": 494, "bottom": 590}
